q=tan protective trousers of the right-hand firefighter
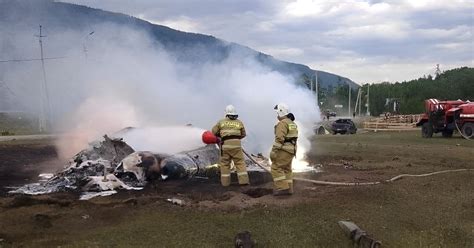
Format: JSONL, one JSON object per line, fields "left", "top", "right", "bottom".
{"left": 270, "top": 149, "right": 295, "bottom": 193}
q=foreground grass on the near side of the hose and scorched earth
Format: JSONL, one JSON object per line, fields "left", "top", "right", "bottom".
{"left": 25, "top": 173, "right": 474, "bottom": 247}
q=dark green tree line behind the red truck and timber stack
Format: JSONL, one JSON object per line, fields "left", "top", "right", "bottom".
{"left": 303, "top": 67, "right": 474, "bottom": 116}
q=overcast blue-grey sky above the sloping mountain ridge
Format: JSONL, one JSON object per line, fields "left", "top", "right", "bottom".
{"left": 64, "top": 0, "right": 474, "bottom": 84}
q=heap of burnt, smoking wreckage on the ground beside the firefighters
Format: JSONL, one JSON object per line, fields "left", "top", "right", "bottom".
{"left": 10, "top": 131, "right": 271, "bottom": 199}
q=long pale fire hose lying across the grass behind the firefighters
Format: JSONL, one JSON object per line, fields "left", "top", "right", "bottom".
{"left": 244, "top": 150, "right": 474, "bottom": 186}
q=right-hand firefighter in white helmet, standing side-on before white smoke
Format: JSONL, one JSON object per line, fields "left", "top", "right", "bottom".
{"left": 270, "top": 103, "right": 298, "bottom": 196}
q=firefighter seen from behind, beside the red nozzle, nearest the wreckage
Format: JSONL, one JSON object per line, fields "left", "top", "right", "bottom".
{"left": 212, "top": 105, "right": 249, "bottom": 186}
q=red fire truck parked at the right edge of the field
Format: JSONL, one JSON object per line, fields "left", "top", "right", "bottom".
{"left": 416, "top": 99, "right": 474, "bottom": 139}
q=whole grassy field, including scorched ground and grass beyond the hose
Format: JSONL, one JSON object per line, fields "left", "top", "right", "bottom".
{"left": 0, "top": 132, "right": 474, "bottom": 247}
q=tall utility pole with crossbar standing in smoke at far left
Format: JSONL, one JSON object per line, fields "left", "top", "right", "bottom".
{"left": 37, "top": 25, "right": 51, "bottom": 132}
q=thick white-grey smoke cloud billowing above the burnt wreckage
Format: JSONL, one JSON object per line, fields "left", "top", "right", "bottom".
{"left": 0, "top": 13, "right": 320, "bottom": 162}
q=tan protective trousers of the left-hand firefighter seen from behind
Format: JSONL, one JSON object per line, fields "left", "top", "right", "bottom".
{"left": 219, "top": 147, "right": 249, "bottom": 186}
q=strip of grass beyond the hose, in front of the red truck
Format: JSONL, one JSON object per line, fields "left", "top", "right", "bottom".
{"left": 308, "top": 131, "right": 474, "bottom": 170}
